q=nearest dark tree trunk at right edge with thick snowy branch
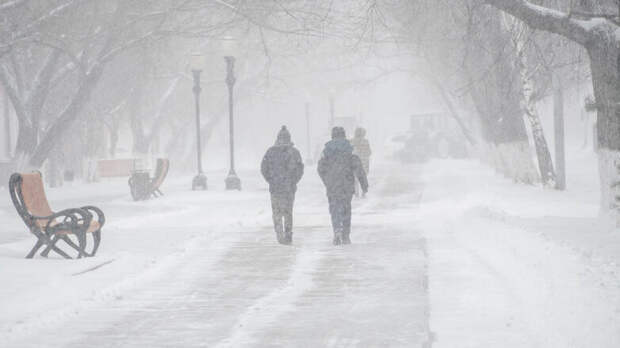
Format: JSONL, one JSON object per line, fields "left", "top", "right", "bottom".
{"left": 485, "top": 0, "right": 620, "bottom": 213}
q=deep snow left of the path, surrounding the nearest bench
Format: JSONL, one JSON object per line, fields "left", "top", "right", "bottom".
{"left": 0, "top": 170, "right": 274, "bottom": 342}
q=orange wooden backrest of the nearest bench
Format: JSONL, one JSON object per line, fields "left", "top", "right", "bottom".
{"left": 9, "top": 172, "right": 53, "bottom": 226}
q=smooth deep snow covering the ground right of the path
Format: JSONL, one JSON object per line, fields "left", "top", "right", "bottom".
{"left": 419, "top": 156, "right": 620, "bottom": 347}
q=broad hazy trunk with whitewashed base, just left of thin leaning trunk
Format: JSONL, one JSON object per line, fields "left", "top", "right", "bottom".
{"left": 464, "top": 9, "right": 537, "bottom": 184}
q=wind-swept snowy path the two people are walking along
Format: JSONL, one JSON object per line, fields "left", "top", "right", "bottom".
{"left": 2, "top": 164, "right": 429, "bottom": 347}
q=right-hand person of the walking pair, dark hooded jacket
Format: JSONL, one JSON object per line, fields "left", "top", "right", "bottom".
{"left": 317, "top": 127, "right": 368, "bottom": 245}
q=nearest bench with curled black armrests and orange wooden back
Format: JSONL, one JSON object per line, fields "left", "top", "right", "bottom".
{"left": 9, "top": 172, "right": 105, "bottom": 259}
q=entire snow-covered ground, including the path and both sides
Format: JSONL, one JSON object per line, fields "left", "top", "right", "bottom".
{"left": 0, "top": 154, "right": 620, "bottom": 347}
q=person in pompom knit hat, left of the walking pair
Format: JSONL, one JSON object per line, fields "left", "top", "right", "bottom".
{"left": 261, "top": 126, "right": 304, "bottom": 245}
